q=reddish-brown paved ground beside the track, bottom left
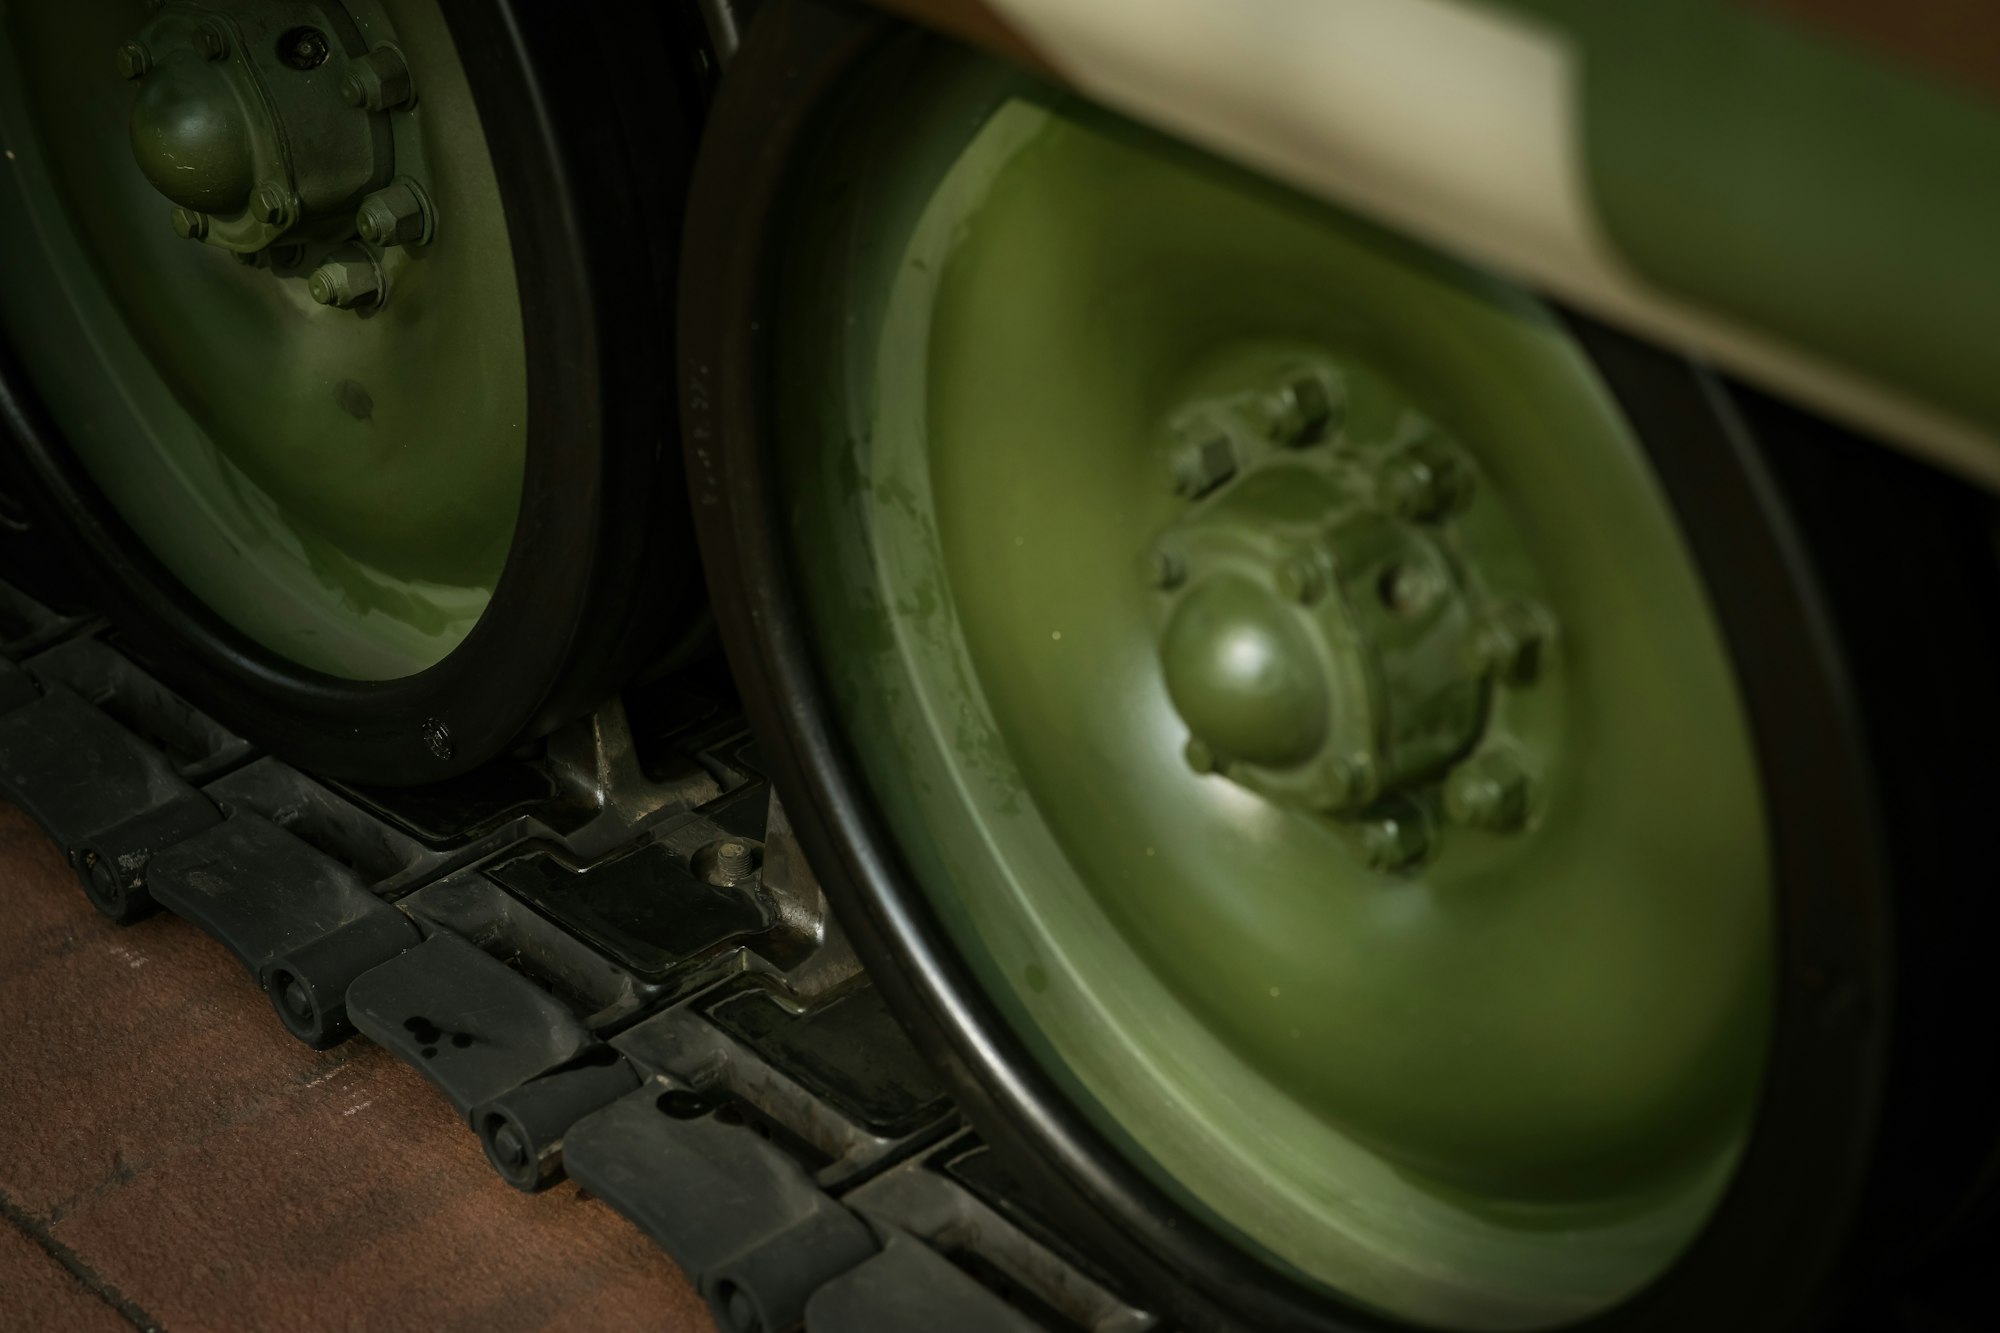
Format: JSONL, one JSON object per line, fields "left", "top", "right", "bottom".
{"left": 0, "top": 807, "right": 712, "bottom": 1333}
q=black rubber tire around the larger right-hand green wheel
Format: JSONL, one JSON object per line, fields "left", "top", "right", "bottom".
{"left": 680, "top": 0, "right": 2000, "bottom": 1333}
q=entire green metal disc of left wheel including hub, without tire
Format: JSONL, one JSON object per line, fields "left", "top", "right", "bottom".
{"left": 0, "top": 0, "right": 526, "bottom": 679}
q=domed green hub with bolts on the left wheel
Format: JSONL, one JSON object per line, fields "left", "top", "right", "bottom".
{"left": 116, "top": 0, "right": 434, "bottom": 308}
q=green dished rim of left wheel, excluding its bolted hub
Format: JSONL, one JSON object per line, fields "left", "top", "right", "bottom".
{"left": 0, "top": 2, "right": 526, "bottom": 681}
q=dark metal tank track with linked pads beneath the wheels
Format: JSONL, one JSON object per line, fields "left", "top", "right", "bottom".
{"left": 0, "top": 584, "right": 1160, "bottom": 1333}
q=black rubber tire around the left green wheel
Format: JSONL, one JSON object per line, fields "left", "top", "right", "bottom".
{"left": 0, "top": 0, "right": 702, "bottom": 785}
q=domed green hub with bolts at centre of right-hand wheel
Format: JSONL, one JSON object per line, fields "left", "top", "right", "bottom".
{"left": 1150, "top": 362, "right": 1552, "bottom": 869}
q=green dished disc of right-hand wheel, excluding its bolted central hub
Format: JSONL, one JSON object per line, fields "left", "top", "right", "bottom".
{"left": 778, "top": 46, "right": 1772, "bottom": 1327}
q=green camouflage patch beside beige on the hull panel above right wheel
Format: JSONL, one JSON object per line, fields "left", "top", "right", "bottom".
{"left": 1482, "top": 0, "right": 2000, "bottom": 430}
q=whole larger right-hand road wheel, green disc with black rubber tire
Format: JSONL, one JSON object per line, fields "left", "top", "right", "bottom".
{"left": 682, "top": 2, "right": 1994, "bottom": 1333}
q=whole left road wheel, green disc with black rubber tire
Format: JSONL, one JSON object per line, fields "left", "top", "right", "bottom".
{"left": 0, "top": 0, "right": 692, "bottom": 781}
